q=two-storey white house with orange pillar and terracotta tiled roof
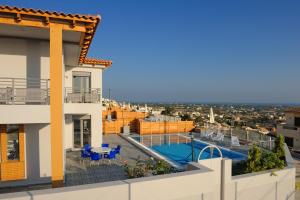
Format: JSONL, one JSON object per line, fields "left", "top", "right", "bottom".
{"left": 0, "top": 6, "right": 112, "bottom": 187}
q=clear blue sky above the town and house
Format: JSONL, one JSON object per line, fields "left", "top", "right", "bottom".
{"left": 0, "top": 0, "right": 300, "bottom": 103}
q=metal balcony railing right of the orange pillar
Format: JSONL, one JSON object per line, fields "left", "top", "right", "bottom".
{"left": 65, "top": 87, "right": 101, "bottom": 103}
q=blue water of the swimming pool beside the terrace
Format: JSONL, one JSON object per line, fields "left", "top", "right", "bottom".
{"left": 133, "top": 137, "right": 247, "bottom": 166}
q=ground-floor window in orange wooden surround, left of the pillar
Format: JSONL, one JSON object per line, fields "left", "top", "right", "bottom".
{"left": 6, "top": 125, "right": 19, "bottom": 160}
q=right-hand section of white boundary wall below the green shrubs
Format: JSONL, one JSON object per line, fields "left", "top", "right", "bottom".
{"left": 222, "top": 146, "right": 296, "bottom": 200}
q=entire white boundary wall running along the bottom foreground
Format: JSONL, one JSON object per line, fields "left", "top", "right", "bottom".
{"left": 0, "top": 145, "right": 295, "bottom": 200}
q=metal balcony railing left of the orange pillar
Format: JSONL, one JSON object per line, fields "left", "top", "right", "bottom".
{"left": 0, "top": 78, "right": 49, "bottom": 104}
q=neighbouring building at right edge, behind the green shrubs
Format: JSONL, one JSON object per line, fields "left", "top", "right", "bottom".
{"left": 277, "top": 107, "right": 300, "bottom": 150}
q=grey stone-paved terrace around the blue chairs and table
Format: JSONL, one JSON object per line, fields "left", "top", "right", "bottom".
{"left": 65, "top": 135, "right": 149, "bottom": 186}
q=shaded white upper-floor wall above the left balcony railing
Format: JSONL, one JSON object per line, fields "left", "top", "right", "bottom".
{"left": 0, "top": 37, "right": 50, "bottom": 79}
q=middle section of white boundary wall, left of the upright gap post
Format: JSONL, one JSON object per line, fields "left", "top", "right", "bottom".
{"left": 126, "top": 159, "right": 221, "bottom": 200}
